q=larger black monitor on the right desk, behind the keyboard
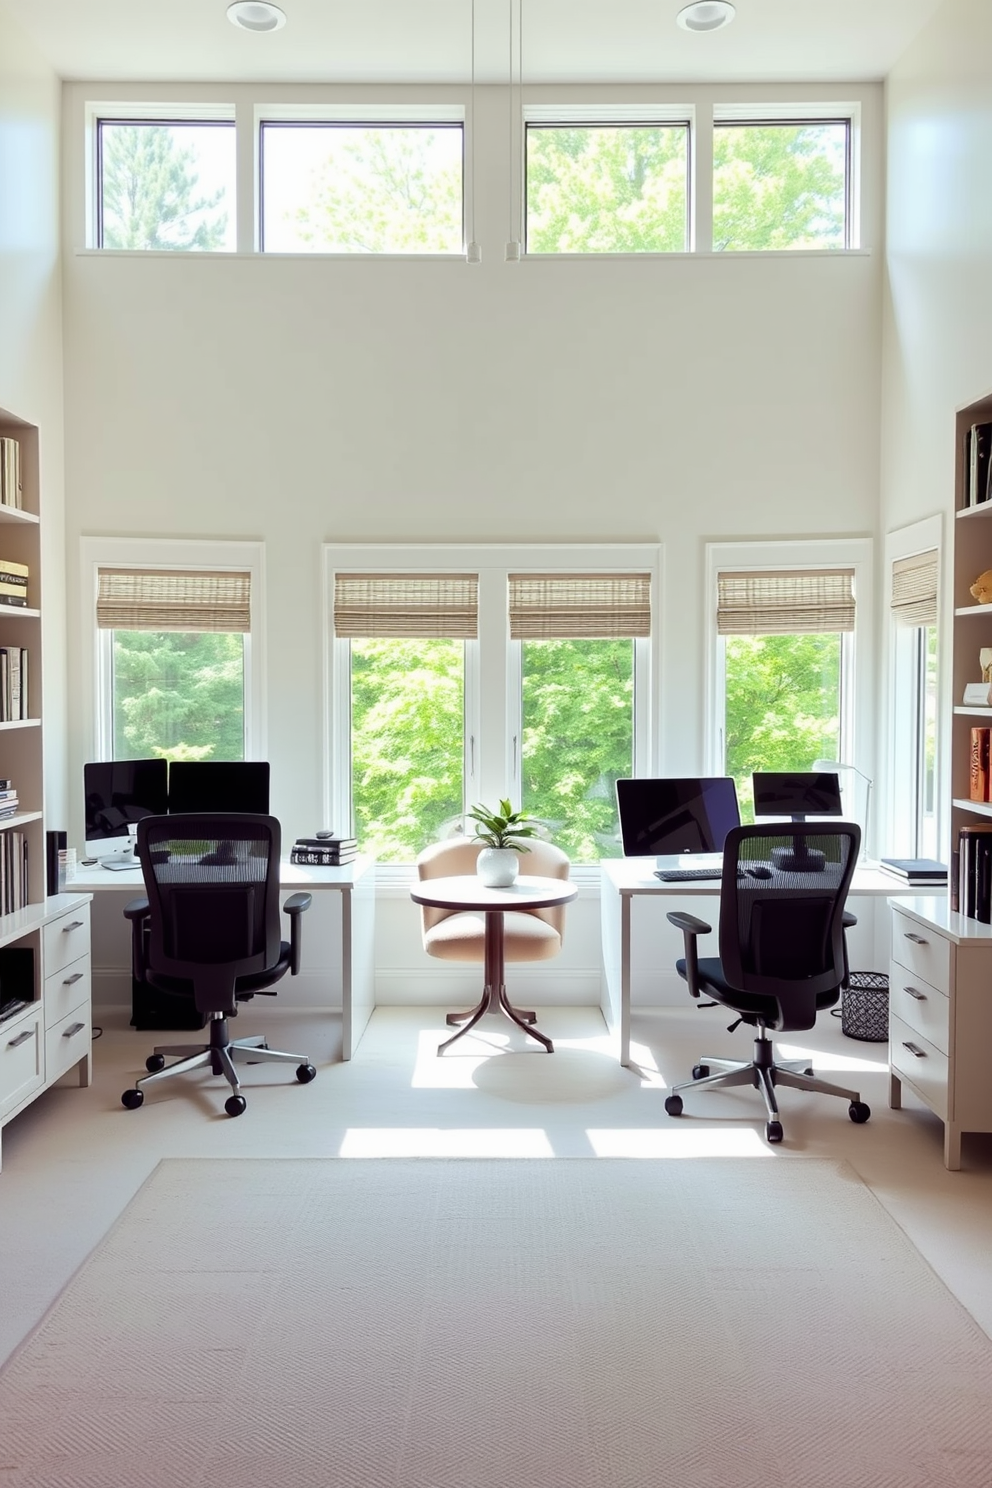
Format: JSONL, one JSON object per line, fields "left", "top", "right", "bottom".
{"left": 617, "top": 775, "right": 741, "bottom": 857}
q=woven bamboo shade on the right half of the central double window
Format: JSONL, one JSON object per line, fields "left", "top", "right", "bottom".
{"left": 509, "top": 573, "right": 651, "bottom": 641}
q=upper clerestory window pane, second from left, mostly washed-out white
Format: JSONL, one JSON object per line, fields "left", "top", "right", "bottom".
{"left": 262, "top": 124, "right": 464, "bottom": 253}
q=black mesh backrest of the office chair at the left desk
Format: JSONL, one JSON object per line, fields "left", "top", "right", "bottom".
{"left": 137, "top": 812, "right": 281, "bottom": 1013}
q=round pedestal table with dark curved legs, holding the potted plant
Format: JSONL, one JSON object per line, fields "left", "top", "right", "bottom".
{"left": 410, "top": 873, "right": 579, "bottom": 1054}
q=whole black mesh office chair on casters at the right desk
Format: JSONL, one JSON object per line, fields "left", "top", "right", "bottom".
{"left": 665, "top": 821, "right": 872, "bottom": 1141}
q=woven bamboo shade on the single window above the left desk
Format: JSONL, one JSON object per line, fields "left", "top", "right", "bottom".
{"left": 97, "top": 568, "right": 251, "bottom": 634}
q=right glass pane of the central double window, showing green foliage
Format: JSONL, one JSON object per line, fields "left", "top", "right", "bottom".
{"left": 521, "top": 640, "right": 634, "bottom": 872}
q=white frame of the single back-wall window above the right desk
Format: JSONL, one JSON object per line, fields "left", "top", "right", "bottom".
{"left": 705, "top": 537, "right": 875, "bottom": 836}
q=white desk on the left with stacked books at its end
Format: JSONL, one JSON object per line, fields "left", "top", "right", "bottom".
{"left": 67, "top": 857, "right": 375, "bottom": 1059}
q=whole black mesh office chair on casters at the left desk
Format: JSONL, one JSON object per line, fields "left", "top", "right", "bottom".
{"left": 120, "top": 812, "right": 317, "bottom": 1116}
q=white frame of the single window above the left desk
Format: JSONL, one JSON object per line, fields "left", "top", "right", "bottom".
{"left": 79, "top": 537, "right": 268, "bottom": 760}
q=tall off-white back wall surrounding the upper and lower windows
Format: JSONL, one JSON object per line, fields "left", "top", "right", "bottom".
{"left": 64, "top": 72, "right": 882, "bottom": 999}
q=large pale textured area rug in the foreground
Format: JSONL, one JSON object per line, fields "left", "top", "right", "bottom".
{"left": 0, "top": 1156, "right": 992, "bottom": 1488}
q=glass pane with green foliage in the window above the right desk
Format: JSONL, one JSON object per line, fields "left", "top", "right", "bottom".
{"left": 724, "top": 634, "right": 842, "bottom": 821}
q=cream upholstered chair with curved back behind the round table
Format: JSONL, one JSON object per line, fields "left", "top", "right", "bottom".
{"left": 416, "top": 836, "right": 570, "bottom": 964}
